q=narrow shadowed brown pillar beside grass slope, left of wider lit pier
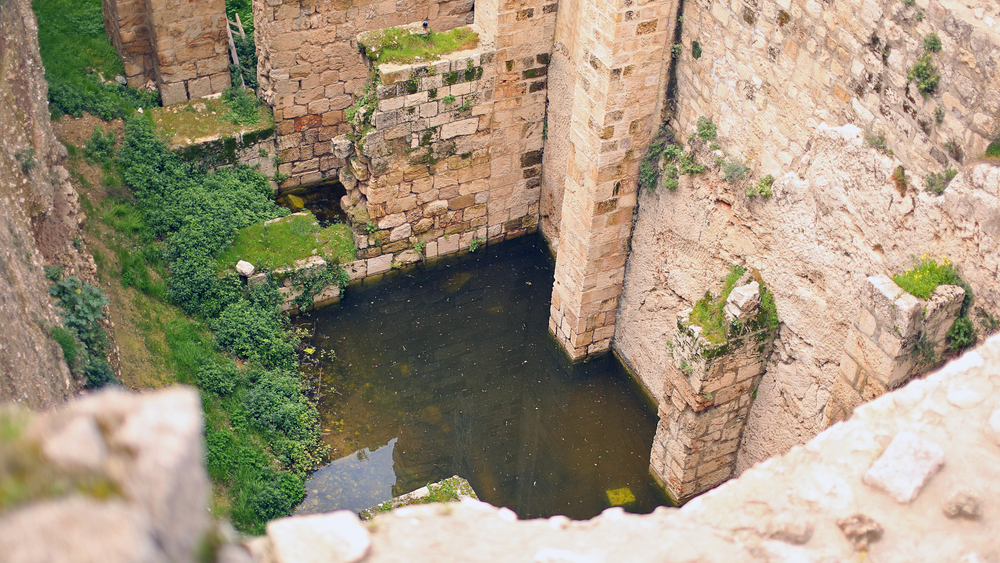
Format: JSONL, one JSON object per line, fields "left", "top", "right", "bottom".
{"left": 101, "top": 0, "right": 153, "bottom": 88}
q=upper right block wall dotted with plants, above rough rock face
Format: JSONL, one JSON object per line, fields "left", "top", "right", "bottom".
{"left": 676, "top": 0, "right": 1000, "bottom": 181}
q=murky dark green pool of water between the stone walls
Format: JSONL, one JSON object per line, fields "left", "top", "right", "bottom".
{"left": 298, "top": 237, "right": 665, "bottom": 518}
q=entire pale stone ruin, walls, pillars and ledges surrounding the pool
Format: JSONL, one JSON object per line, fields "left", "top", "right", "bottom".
{"left": 0, "top": 0, "right": 1000, "bottom": 562}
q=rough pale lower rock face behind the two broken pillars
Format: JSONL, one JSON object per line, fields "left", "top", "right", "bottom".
{"left": 614, "top": 122, "right": 1000, "bottom": 471}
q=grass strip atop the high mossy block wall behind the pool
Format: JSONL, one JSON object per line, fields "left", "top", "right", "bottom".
{"left": 359, "top": 27, "right": 479, "bottom": 64}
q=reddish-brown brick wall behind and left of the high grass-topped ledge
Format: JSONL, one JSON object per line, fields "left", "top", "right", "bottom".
{"left": 253, "top": 0, "right": 473, "bottom": 189}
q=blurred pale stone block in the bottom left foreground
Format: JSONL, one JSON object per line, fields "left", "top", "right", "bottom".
{"left": 0, "top": 387, "right": 211, "bottom": 562}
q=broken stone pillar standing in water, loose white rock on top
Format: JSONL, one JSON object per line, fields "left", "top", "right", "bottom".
{"left": 649, "top": 276, "right": 777, "bottom": 502}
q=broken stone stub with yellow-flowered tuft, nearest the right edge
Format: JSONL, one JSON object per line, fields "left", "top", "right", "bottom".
{"left": 824, "top": 276, "right": 965, "bottom": 426}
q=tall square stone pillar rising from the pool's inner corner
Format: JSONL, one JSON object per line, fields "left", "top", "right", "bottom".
{"left": 549, "top": 0, "right": 676, "bottom": 360}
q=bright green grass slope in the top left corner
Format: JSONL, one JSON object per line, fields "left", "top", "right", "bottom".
{"left": 32, "top": 0, "right": 160, "bottom": 119}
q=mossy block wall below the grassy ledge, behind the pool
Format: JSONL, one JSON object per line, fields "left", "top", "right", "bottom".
{"left": 335, "top": 0, "right": 555, "bottom": 264}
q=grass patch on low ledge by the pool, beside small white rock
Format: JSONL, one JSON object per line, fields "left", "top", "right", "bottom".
{"left": 217, "top": 213, "right": 354, "bottom": 272}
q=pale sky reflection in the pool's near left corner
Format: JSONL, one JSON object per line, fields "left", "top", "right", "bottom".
{"left": 295, "top": 438, "right": 397, "bottom": 514}
